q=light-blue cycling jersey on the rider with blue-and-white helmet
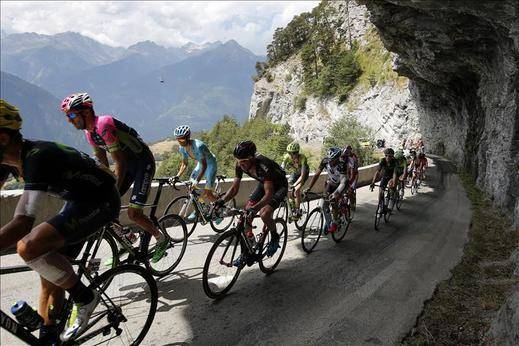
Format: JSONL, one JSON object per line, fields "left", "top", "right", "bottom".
{"left": 178, "top": 139, "right": 217, "bottom": 190}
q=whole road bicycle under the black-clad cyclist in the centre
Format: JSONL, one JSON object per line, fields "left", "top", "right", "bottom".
{"left": 202, "top": 209, "right": 287, "bottom": 299}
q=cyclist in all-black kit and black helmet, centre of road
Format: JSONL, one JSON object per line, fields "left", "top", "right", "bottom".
{"left": 215, "top": 141, "right": 288, "bottom": 267}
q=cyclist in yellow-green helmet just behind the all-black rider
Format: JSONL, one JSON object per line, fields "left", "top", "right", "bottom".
{"left": 281, "top": 142, "right": 310, "bottom": 220}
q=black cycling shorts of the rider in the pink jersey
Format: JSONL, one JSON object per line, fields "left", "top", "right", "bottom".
{"left": 119, "top": 157, "right": 155, "bottom": 208}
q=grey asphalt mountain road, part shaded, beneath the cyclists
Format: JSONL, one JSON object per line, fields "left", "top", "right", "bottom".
{"left": 0, "top": 158, "right": 471, "bottom": 345}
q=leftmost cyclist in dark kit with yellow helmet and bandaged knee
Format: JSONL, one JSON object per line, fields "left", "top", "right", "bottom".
{"left": 0, "top": 100, "right": 121, "bottom": 343}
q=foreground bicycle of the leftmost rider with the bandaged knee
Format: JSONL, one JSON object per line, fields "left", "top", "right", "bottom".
{"left": 0, "top": 224, "right": 158, "bottom": 345}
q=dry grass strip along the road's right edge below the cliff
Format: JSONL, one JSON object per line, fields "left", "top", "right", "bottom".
{"left": 402, "top": 172, "right": 519, "bottom": 345}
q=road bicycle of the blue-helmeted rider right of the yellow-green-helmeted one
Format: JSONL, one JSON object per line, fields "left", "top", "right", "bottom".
{"left": 301, "top": 192, "right": 351, "bottom": 253}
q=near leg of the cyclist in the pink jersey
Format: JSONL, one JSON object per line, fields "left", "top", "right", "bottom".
{"left": 128, "top": 160, "right": 164, "bottom": 241}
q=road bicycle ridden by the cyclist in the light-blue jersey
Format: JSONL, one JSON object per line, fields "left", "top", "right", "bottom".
{"left": 164, "top": 175, "right": 236, "bottom": 240}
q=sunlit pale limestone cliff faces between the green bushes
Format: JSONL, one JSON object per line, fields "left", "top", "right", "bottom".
{"left": 249, "top": 0, "right": 420, "bottom": 145}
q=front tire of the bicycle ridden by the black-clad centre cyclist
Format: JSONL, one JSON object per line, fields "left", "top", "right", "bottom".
{"left": 202, "top": 228, "right": 243, "bottom": 299}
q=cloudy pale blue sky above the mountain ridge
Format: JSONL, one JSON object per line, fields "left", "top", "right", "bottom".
{"left": 0, "top": 1, "right": 319, "bottom": 54}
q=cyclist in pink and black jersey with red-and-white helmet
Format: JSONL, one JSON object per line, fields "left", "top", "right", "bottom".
{"left": 61, "top": 93, "right": 168, "bottom": 263}
